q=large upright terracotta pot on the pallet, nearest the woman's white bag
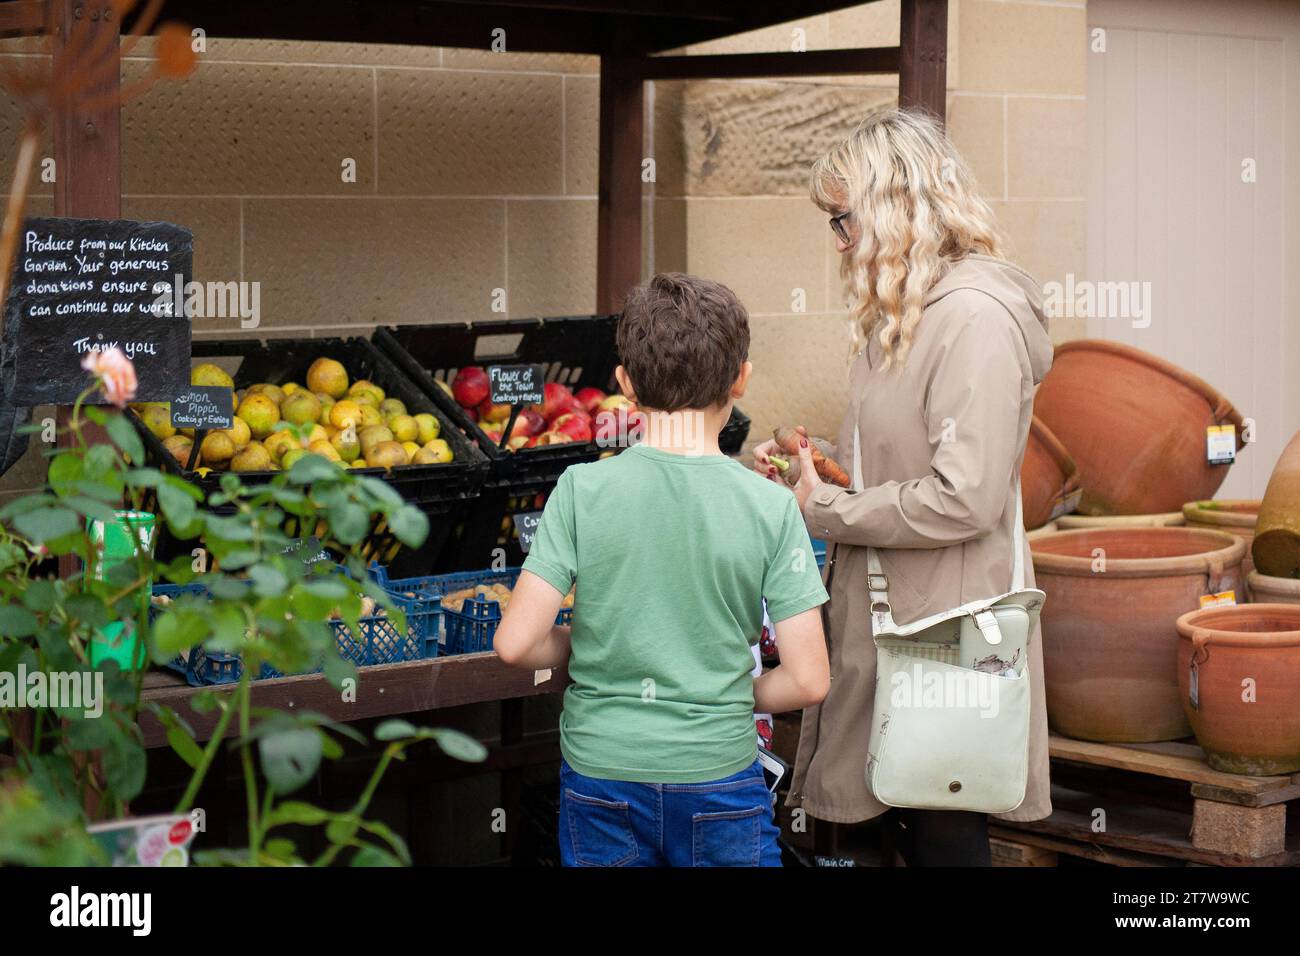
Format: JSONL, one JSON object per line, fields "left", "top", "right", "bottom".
{"left": 1030, "top": 528, "right": 1245, "bottom": 743}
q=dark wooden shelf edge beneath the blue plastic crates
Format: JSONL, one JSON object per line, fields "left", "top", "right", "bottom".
{"left": 140, "top": 652, "right": 568, "bottom": 748}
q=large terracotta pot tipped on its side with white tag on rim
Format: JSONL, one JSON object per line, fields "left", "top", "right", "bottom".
{"left": 1034, "top": 339, "right": 1244, "bottom": 515}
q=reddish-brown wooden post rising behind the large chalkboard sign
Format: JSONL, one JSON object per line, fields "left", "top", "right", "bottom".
{"left": 49, "top": 0, "right": 122, "bottom": 578}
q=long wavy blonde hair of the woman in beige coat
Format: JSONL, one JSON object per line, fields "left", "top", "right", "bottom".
{"left": 810, "top": 108, "right": 1002, "bottom": 368}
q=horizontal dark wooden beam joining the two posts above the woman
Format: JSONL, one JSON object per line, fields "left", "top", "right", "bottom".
{"left": 629, "top": 47, "right": 901, "bottom": 79}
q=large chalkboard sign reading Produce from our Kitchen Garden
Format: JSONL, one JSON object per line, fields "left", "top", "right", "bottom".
{"left": 3, "top": 219, "right": 194, "bottom": 406}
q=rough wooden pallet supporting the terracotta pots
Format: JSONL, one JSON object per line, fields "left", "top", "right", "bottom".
{"left": 991, "top": 735, "right": 1300, "bottom": 866}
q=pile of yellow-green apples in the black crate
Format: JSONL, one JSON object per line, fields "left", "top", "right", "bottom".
{"left": 131, "top": 358, "right": 452, "bottom": 475}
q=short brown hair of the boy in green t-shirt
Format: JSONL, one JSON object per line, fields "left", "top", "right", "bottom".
{"left": 618, "top": 272, "right": 749, "bottom": 411}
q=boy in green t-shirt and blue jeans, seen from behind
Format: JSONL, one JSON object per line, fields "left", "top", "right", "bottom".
{"left": 495, "top": 273, "right": 829, "bottom": 866}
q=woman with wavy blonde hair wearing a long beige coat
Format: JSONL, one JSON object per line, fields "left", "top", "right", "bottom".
{"left": 754, "top": 109, "right": 1052, "bottom": 866}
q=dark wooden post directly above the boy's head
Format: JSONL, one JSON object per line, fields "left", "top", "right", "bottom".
{"left": 595, "top": 44, "right": 645, "bottom": 313}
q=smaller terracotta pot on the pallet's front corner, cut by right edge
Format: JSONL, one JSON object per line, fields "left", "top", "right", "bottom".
{"left": 1178, "top": 604, "right": 1300, "bottom": 775}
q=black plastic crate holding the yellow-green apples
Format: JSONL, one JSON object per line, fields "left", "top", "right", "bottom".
{"left": 127, "top": 338, "right": 488, "bottom": 574}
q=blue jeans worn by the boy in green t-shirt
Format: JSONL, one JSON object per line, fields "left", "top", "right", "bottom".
{"left": 560, "top": 760, "right": 781, "bottom": 866}
